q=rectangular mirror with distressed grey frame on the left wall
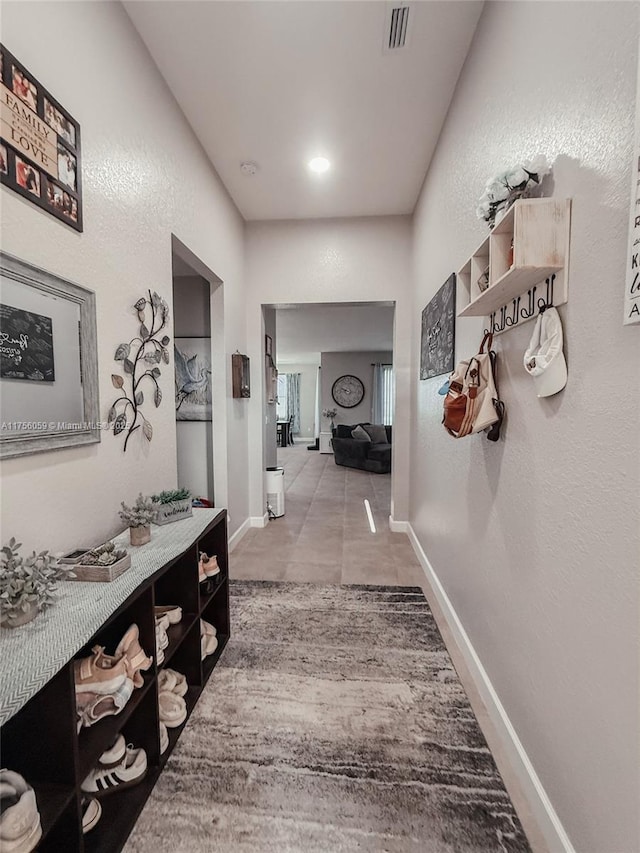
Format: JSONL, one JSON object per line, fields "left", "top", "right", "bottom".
{"left": 0, "top": 252, "right": 103, "bottom": 458}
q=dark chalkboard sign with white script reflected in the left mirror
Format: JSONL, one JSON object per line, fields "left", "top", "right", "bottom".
{"left": 0, "top": 305, "right": 56, "bottom": 382}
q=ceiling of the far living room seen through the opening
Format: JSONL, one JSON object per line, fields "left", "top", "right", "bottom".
{"left": 276, "top": 304, "right": 394, "bottom": 364}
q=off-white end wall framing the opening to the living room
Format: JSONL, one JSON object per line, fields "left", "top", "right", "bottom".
{"left": 246, "top": 216, "right": 411, "bottom": 519}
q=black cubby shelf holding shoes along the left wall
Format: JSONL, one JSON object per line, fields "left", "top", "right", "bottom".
{"left": 1, "top": 510, "right": 230, "bottom": 853}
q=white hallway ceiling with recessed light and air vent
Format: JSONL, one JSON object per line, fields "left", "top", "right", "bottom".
{"left": 124, "top": 0, "right": 482, "bottom": 220}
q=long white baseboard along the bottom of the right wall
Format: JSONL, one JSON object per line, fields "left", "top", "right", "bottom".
{"left": 408, "top": 519, "right": 575, "bottom": 853}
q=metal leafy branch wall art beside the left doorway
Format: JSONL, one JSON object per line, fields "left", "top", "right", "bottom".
{"left": 107, "top": 290, "right": 170, "bottom": 451}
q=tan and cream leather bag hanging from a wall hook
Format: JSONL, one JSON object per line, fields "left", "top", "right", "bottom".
{"left": 442, "top": 332, "right": 504, "bottom": 441}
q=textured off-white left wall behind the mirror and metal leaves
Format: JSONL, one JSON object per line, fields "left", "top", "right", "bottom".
{"left": 1, "top": 2, "right": 248, "bottom": 550}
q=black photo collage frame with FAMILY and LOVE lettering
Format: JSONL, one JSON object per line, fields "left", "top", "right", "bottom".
{"left": 0, "top": 45, "right": 82, "bottom": 231}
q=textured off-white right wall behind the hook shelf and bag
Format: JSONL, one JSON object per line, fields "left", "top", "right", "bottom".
{"left": 410, "top": 3, "right": 640, "bottom": 853}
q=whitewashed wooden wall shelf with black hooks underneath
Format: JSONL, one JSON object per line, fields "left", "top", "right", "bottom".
{"left": 458, "top": 198, "right": 571, "bottom": 334}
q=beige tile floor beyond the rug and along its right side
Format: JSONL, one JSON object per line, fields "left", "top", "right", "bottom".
{"left": 229, "top": 442, "right": 549, "bottom": 853}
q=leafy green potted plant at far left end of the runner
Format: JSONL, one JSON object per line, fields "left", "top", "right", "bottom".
{"left": 0, "top": 537, "right": 74, "bottom": 628}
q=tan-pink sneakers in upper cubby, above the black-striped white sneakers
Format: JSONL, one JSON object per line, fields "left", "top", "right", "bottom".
{"left": 73, "top": 624, "right": 153, "bottom": 730}
